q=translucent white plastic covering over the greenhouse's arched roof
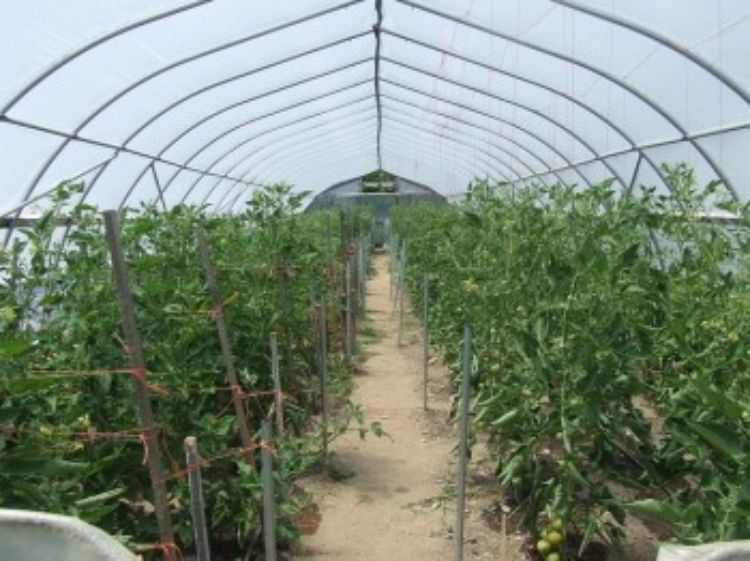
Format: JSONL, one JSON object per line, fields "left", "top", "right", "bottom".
{"left": 0, "top": 0, "right": 750, "bottom": 230}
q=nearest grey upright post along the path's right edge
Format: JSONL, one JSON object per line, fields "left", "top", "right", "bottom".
{"left": 453, "top": 325, "right": 471, "bottom": 561}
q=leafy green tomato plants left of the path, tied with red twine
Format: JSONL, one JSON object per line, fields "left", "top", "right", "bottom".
{"left": 0, "top": 184, "right": 376, "bottom": 559}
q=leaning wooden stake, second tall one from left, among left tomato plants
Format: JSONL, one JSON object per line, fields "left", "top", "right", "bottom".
{"left": 195, "top": 226, "right": 254, "bottom": 456}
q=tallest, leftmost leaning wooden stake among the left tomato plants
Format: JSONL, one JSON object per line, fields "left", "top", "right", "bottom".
{"left": 104, "top": 210, "right": 174, "bottom": 558}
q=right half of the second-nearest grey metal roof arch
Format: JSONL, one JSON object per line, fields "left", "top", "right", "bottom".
{"left": 394, "top": 0, "right": 739, "bottom": 200}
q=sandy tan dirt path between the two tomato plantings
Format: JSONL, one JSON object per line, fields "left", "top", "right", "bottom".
{"left": 293, "top": 255, "right": 518, "bottom": 561}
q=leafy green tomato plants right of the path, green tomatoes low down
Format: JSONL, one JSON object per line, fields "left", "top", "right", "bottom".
{"left": 392, "top": 166, "right": 750, "bottom": 561}
